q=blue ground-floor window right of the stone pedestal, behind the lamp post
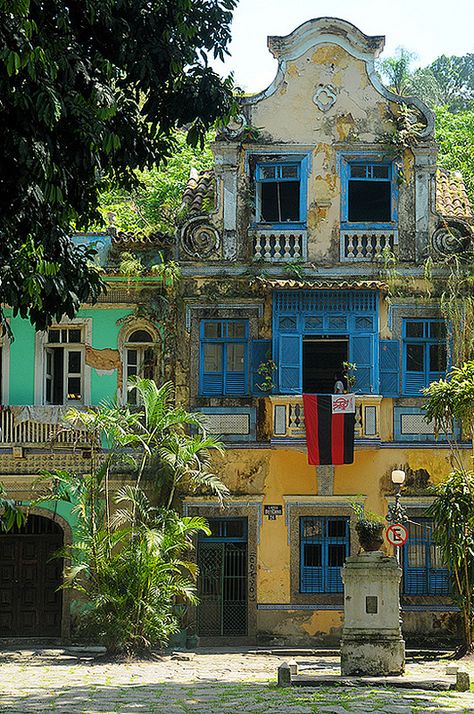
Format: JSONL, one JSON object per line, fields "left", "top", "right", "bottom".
{"left": 403, "top": 518, "right": 451, "bottom": 595}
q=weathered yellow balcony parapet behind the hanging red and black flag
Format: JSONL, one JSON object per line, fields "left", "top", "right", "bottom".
{"left": 270, "top": 395, "right": 382, "bottom": 442}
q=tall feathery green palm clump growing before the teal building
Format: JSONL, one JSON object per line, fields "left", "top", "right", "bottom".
{"left": 38, "top": 378, "right": 228, "bottom": 652}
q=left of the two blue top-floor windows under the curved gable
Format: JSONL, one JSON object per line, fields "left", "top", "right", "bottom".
{"left": 255, "top": 157, "right": 307, "bottom": 228}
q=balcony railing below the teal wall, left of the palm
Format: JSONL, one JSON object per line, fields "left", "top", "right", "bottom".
{"left": 0, "top": 406, "right": 93, "bottom": 447}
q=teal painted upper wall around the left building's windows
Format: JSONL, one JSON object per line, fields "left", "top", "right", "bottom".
{"left": 8, "top": 307, "right": 132, "bottom": 404}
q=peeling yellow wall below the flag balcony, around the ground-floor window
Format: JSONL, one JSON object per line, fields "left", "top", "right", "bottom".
{"left": 215, "top": 447, "right": 460, "bottom": 616}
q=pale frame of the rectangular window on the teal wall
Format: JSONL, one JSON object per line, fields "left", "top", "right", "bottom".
{"left": 35, "top": 317, "right": 92, "bottom": 406}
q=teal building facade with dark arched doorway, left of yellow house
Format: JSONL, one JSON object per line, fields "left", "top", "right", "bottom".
{"left": 0, "top": 230, "right": 164, "bottom": 638}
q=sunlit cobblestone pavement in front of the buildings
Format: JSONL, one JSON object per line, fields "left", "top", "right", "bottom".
{"left": 0, "top": 650, "right": 474, "bottom": 714}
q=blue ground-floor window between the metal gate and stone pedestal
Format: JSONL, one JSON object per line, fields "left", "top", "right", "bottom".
{"left": 300, "top": 516, "right": 349, "bottom": 593}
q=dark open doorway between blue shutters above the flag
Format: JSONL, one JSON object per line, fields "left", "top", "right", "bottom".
{"left": 303, "top": 336, "right": 349, "bottom": 394}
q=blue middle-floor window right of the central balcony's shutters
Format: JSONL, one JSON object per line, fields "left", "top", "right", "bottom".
{"left": 403, "top": 318, "right": 447, "bottom": 396}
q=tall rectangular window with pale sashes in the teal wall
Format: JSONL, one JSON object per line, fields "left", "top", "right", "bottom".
{"left": 44, "top": 325, "right": 84, "bottom": 404}
